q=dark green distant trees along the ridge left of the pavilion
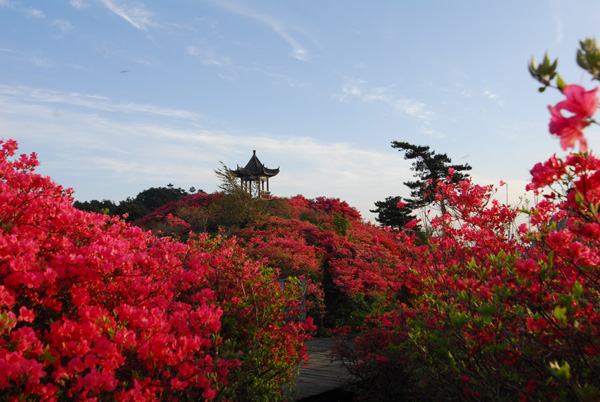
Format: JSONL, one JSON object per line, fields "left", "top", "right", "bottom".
{"left": 73, "top": 183, "right": 205, "bottom": 222}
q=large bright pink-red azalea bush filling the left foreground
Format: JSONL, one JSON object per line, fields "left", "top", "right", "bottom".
{"left": 0, "top": 140, "right": 313, "bottom": 401}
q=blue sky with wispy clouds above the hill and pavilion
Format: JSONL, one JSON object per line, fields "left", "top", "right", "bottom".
{"left": 0, "top": 0, "right": 600, "bottom": 219}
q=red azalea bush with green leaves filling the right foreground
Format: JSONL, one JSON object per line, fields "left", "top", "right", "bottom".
{"left": 336, "top": 41, "right": 600, "bottom": 401}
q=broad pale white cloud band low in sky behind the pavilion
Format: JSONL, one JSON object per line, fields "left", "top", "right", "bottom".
{"left": 0, "top": 82, "right": 411, "bottom": 219}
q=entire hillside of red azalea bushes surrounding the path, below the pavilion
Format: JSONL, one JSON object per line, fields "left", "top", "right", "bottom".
{"left": 5, "top": 39, "right": 600, "bottom": 401}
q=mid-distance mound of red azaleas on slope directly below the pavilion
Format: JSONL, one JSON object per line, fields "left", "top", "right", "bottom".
{"left": 237, "top": 201, "right": 420, "bottom": 328}
